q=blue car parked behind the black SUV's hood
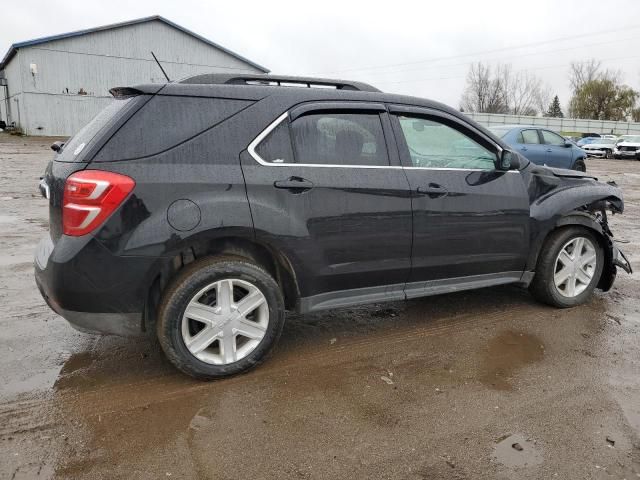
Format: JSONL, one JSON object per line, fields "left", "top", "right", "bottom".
{"left": 489, "top": 125, "right": 587, "bottom": 172}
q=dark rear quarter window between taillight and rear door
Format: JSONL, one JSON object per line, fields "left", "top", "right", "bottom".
{"left": 95, "top": 95, "right": 253, "bottom": 162}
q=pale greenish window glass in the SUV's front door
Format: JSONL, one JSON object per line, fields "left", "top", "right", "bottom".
{"left": 398, "top": 116, "right": 497, "bottom": 170}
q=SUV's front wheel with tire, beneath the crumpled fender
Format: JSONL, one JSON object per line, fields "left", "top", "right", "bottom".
{"left": 529, "top": 227, "right": 604, "bottom": 308}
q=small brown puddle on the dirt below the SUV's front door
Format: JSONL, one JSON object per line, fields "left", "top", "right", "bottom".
{"left": 480, "top": 331, "right": 544, "bottom": 390}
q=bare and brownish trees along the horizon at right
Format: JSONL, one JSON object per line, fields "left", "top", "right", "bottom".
{"left": 460, "top": 60, "right": 640, "bottom": 122}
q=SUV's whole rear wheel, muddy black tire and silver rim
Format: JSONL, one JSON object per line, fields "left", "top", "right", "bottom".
{"left": 157, "top": 257, "right": 284, "bottom": 380}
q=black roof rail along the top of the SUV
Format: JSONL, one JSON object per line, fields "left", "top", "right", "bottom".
{"left": 180, "top": 73, "right": 380, "bottom": 92}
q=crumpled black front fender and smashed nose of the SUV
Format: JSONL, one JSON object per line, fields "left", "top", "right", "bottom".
{"left": 527, "top": 164, "right": 632, "bottom": 292}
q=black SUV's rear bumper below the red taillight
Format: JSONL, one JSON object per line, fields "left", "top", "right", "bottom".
{"left": 34, "top": 235, "right": 156, "bottom": 336}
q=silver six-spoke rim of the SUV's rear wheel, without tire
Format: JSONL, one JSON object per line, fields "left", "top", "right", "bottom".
{"left": 182, "top": 279, "right": 269, "bottom": 365}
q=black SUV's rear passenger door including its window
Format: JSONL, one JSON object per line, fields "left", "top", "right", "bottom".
{"left": 241, "top": 102, "right": 412, "bottom": 310}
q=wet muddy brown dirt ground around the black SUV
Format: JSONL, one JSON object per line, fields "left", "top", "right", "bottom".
{"left": 0, "top": 134, "right": 640, "bottom": 479}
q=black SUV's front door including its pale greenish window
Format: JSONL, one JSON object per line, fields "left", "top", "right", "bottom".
{"left": 391, "top": 107, "right": 529, "bottom": 296}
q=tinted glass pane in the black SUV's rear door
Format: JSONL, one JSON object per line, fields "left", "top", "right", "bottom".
{"left": 291, "top": 113, "right": 389, "bottom": 166}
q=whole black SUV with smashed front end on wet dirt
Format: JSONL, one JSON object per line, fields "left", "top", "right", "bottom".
{"left": 35, "top": 75, "right": 631, "bottom": 378}
